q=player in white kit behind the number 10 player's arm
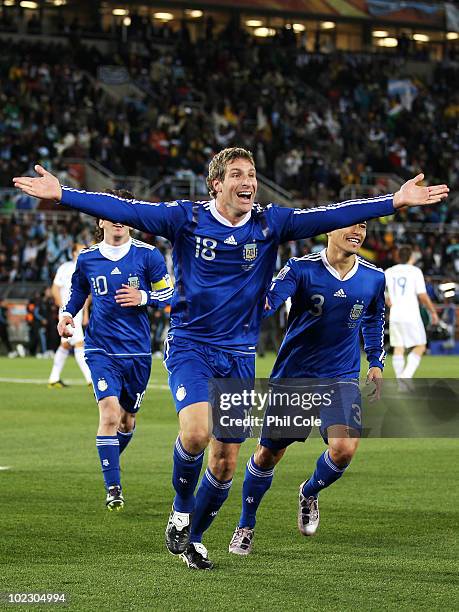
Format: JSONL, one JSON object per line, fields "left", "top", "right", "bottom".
{"left": 48, "top": 243, "right": 92, "bottom": 389}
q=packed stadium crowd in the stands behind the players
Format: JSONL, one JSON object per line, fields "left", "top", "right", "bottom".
{"left": 0, "top": 23, "right": 459, "bottom": 354}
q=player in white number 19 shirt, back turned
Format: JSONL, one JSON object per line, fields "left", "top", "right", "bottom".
{"left": 385, "top": 246, "right": 438, "bottom": 378}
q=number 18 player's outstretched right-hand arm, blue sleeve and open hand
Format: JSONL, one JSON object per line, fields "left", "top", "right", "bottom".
{"left": 275, "top": 174, "right": 449, "bottom": 242}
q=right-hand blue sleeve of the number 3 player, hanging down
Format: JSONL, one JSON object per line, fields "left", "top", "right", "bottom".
{"left": 362, "top": 274, "right": 386, "bottom": 370}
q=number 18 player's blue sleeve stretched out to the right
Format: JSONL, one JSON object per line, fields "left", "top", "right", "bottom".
{"left": 272, "top": 195, "right": 395, "bottom": 242}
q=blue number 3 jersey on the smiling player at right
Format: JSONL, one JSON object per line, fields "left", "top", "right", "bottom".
{"left": 265, "top": 249, "right": 385, "bottom": 378}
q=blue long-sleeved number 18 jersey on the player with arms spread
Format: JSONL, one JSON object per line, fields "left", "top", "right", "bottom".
{"left": 61, "top": 187, "right": 394, "bottom": 353}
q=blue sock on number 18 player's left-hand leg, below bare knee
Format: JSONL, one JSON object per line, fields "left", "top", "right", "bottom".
{"left": 172, "top": 436, "right": 204, "bottom": 512}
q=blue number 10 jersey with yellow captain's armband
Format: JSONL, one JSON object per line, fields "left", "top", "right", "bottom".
{"left": 64, "top": 239, "right": 173, "bottom": 357}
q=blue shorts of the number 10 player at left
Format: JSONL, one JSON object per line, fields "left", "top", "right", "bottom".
{"left": 85, "top": 351, "right": 151, "bottom": 414}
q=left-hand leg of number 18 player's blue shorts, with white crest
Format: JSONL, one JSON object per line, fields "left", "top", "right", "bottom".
{"left": 164, "top": 337, "right": 215, "bottom": 413}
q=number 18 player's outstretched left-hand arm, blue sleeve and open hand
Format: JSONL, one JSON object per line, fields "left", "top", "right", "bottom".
{"left": 13, "top": 165, "right": 186, "bottom": 241}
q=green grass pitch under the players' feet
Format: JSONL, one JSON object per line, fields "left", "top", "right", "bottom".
{"left": 0, "top": 356, "right": 459, "bottom": 612}
